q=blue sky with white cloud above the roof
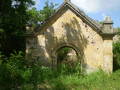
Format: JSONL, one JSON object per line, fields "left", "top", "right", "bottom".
{"left": 34, "top": 0, "right": 120, "bottom": 27}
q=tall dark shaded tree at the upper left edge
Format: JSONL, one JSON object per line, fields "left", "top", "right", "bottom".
{"left": 0, "top": 0, "right": 34, "bottom": 55}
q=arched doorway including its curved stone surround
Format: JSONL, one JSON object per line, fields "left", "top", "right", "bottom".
{"left": 52, "top": 44, "right": 83, "bottom": 70}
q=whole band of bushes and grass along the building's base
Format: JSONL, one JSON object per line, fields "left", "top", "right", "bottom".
{"left": 0, "top": 52, "right": 120, "bottom": 90}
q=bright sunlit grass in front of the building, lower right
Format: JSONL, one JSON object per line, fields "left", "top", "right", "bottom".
{"left": 48, "top": 71, "right": 120, "bottom": 90}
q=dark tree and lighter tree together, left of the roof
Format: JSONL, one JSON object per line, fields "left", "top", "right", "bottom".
{"left": 0, "top": 0, "right": 56, "bottom": 56}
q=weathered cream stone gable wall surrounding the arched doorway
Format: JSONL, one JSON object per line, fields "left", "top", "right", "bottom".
{"left": 26, "top": 9, "right": 112, "bottom": 72}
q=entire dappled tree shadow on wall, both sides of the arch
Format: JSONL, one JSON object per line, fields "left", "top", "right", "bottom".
{"left": 40, "top": 17, "right": 87, "bottom": 65}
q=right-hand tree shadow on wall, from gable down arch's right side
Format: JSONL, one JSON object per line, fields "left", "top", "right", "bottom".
{"left": 59, "top": 17, "right": 88, "bottom": 65}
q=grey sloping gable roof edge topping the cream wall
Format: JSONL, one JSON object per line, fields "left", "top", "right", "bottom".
{"left": 34, "top": 1, "right": 102, "bottom": 35}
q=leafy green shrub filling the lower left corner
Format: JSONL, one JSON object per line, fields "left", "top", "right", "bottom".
{"left": 0, "top": 52, "right": 31, "bottom": 90}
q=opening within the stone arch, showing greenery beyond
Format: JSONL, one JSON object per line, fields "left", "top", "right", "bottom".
{"left": 56, "top": 46, "right": 79, "bottom": 65}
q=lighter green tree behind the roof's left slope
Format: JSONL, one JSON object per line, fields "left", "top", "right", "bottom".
{"left": 28, "top": 0, "right": 57, "bottom": 27}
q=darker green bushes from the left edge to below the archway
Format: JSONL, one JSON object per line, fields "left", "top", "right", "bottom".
{"left": 0, "top": 52, "right": 80, "bottom": 90}
